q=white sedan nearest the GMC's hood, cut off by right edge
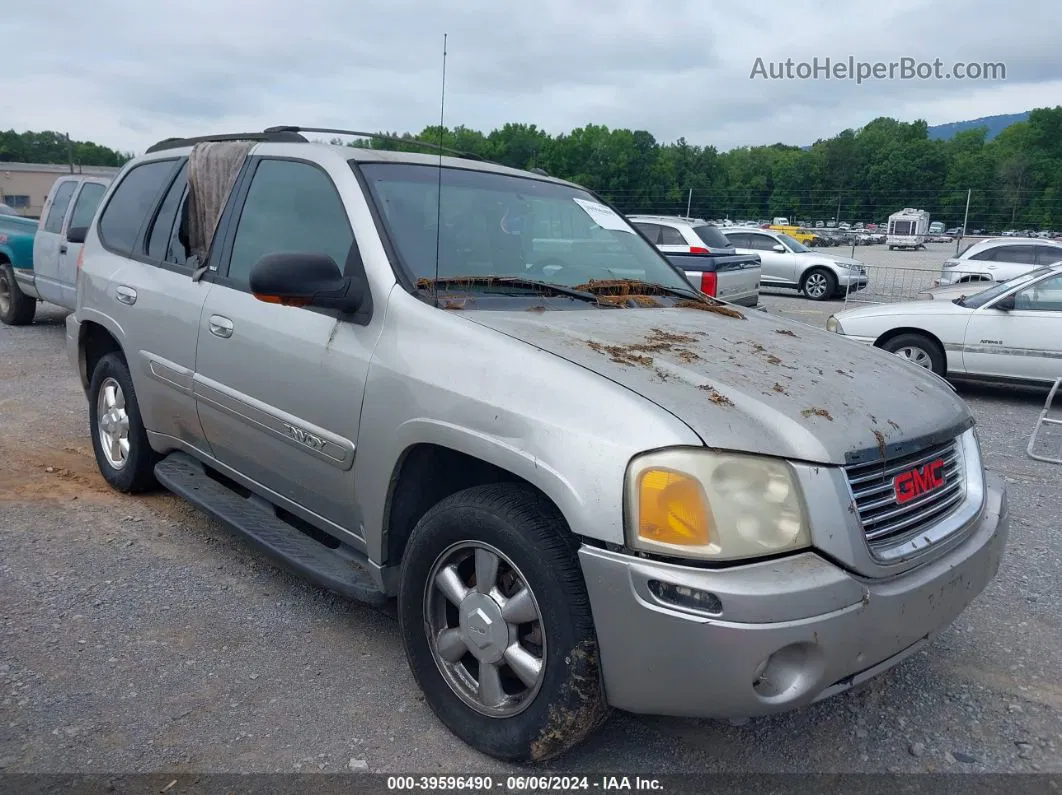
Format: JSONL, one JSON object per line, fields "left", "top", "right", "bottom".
{"left": 826, "top": 263, "right": 1062, "bottom": 384}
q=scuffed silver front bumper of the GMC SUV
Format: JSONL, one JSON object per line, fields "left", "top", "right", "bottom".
{"left": 579, "top": 474, "right": 1009, "bottom": 719}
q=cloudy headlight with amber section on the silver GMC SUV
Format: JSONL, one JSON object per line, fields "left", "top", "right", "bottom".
{"left": 627, "top": 449, "right": 811, "bottom": 560}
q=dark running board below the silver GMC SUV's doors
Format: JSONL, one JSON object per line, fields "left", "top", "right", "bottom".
{"left": 155, "top": 452, "right": 387, "bottom": 605}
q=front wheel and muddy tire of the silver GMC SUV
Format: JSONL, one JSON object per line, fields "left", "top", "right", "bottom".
{"left": 398, "top": 484, "right": 609, "bottom": 762}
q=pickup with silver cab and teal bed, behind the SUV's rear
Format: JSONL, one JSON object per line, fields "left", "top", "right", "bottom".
{"left": 0, "top": 174, "right": 110, "bottom": 326}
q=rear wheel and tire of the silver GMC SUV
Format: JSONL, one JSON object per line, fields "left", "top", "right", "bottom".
{"left": 88, "top": 353, "right": 159, "bottom": 494}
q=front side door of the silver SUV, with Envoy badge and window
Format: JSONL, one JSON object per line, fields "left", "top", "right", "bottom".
{"left": 194, "top": 157, "right": 379, "bottom": 536}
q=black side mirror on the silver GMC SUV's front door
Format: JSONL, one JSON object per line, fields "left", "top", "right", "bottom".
{"left": 250, "top": 252, "right": 367, "bottom": 313}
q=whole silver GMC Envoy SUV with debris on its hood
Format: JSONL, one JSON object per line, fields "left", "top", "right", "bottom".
{"left": 67, "top": 127, "right": 1008, "bottom": 761}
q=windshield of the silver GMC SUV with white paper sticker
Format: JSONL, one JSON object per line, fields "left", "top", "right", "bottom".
{"left": 352, "top": 161, "right": 690, "bottom": 293}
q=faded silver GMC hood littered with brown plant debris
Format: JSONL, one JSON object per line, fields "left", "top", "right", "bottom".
{"left": 462, "top": 304, "right": 973, "bottom": 465}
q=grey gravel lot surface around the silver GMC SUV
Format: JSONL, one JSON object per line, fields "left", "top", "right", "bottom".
{"left": 0, "top": 295, "right": 1062, "bottom": 774}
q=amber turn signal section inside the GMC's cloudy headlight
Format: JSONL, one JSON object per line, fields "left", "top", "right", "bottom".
{"left": 638, "top": 469, "right": 712, "bottom": 547}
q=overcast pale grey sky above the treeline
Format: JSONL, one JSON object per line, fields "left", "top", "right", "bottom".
{"left": 6, "top": 0, "right": 1062, "bottom": 152}
